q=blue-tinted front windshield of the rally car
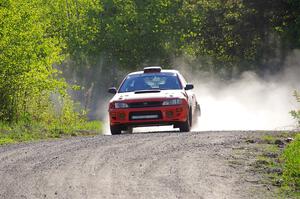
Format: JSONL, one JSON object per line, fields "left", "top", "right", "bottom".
{"left": 119, "top": 73, "right": 182, "bottom": 93}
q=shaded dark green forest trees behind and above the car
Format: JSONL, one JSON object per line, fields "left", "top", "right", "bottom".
{"left": 54, "top": 0, "right": 299, "bottom": 72}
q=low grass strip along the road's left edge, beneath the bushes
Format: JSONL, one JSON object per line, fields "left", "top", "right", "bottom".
{"left": 0, "top": 121, "right": 102, "bottom": 145}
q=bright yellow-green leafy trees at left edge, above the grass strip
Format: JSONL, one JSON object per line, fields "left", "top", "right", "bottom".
{"left": 0, "top": 0, "right": 67, "bottom": 121}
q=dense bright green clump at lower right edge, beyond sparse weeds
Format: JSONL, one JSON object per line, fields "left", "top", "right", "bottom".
{"left": 283, "top": 134, "right": 300, "bottom": 192}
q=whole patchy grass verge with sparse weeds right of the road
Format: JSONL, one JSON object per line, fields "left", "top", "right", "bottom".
{"left": 254, "top": 133, "right": 300, "bottom": 198}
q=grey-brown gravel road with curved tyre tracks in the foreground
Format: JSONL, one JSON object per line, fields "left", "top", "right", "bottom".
{"left": 0, "top": 131, "right": 276, "bottom": 199}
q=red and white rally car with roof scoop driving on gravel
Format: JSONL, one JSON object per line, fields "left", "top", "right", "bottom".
{"left": 108, "top": 66, "right": 201, "bottom": 135}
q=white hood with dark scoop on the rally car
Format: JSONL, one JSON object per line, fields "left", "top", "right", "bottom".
{"left": 111, "top": 90, "right": 186, "bottom": 101}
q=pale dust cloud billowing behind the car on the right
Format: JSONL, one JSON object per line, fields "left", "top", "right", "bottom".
{"left": 190, "top": 52, "right": 300, "bottom": 131}
